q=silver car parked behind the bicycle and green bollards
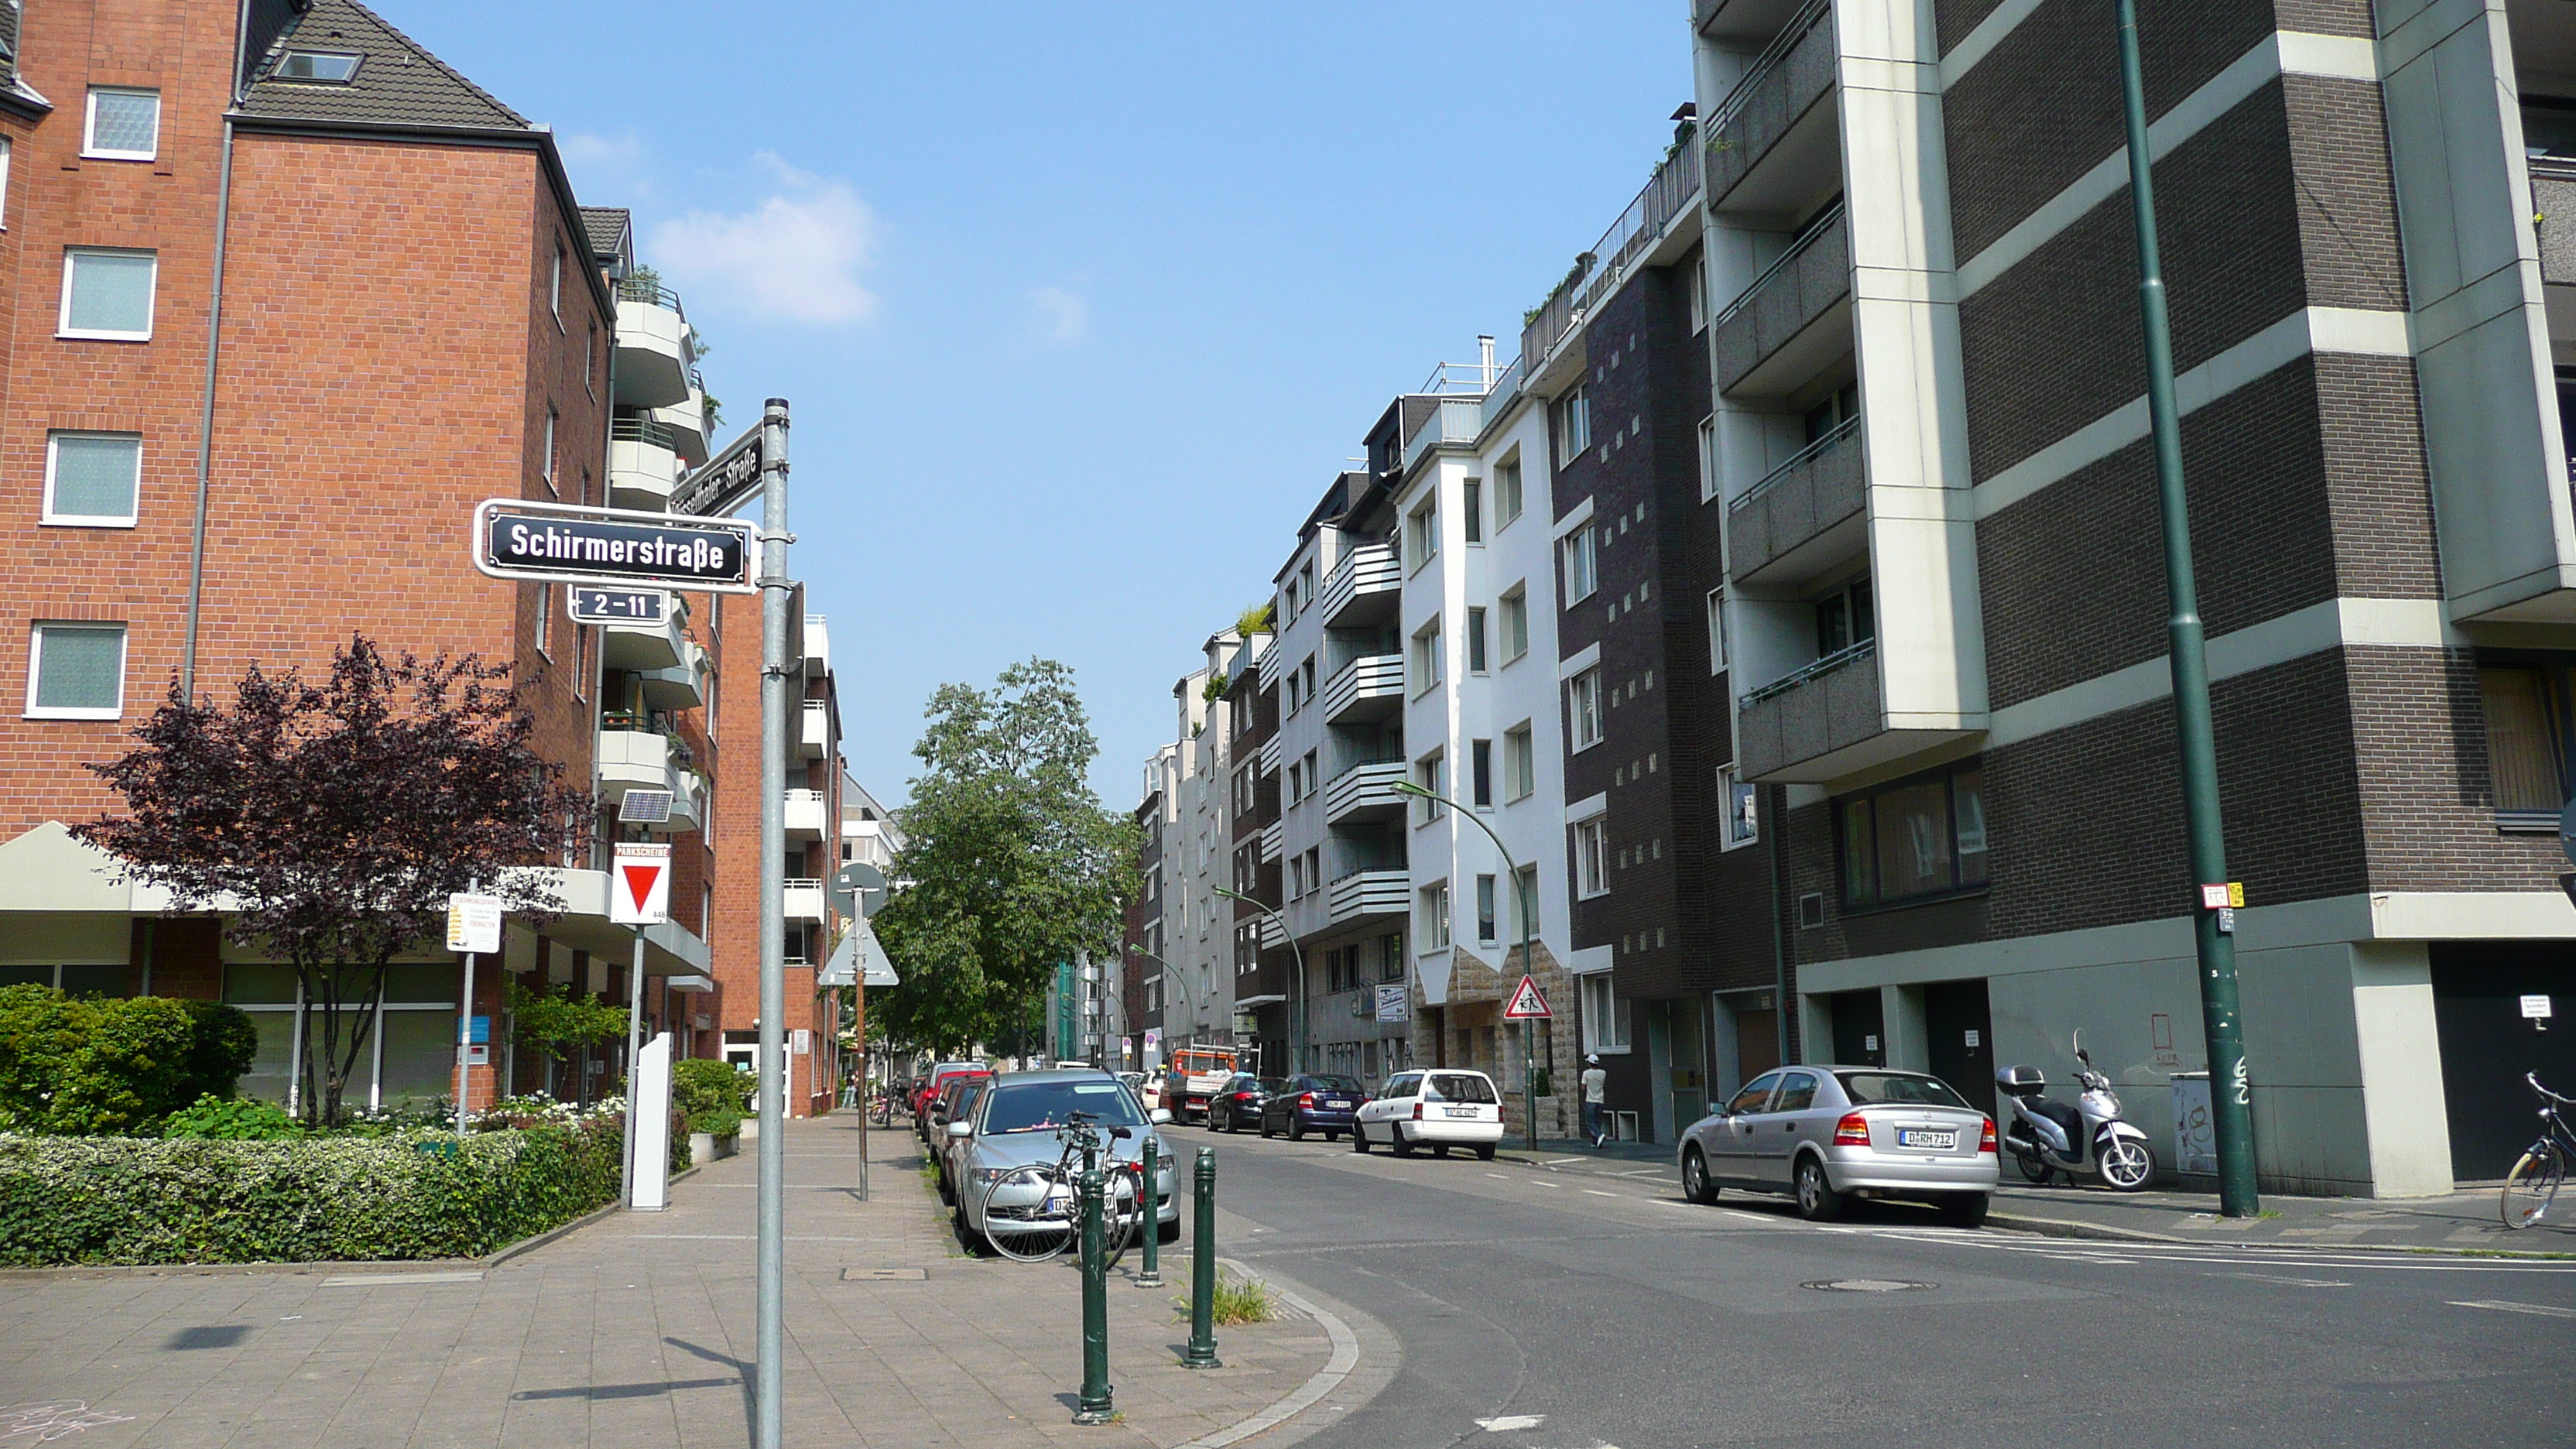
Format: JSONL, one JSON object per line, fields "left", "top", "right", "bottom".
{"left": 948, "top": 1070, "right": 1180, "bottom": 1243}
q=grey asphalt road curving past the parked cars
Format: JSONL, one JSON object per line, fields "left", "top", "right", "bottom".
{"left": 1195, "top": 1129, "right": 2576, "bottom": 1449}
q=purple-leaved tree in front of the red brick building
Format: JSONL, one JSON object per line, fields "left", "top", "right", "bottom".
{"left": 72, "top": 634, "right": 592, "bottom": 1124}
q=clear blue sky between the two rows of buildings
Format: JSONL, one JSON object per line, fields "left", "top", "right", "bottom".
{"left": 402, "top": 0, "right": 1690, "bottom": 810}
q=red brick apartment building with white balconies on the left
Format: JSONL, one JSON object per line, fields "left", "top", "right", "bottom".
{"left": 0, "top": 0, "right": 838, "bottom": 1106}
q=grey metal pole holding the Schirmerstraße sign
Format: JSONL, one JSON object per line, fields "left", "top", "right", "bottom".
{"left": 752, "top": 397, "right": 793, "bottom": 1449}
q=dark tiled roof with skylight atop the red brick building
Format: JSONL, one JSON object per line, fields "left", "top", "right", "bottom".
{"left": 242, "top": 0, "right": 528, "bottom": 132}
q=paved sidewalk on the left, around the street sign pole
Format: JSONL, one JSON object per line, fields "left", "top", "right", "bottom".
{"left": 0, "top": 1116, "right": 1332, "bottom": 1449}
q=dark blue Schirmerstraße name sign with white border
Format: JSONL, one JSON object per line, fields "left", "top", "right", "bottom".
{"left": 471, "top": 498, "right": 760, "bottom": 593}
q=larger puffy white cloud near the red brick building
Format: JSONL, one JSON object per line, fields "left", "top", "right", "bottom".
{"left": 646, "top": 152, "right": 879, "bottom": 325}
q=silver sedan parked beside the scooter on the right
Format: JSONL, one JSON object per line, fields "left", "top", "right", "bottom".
{"left": 1677, "top": 1065, "right": 1999, "bottom": 1228}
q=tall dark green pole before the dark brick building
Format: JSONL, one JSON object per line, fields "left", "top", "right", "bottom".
{"left": 2115, "top": 0, "right": 2262, "bottom": 1217}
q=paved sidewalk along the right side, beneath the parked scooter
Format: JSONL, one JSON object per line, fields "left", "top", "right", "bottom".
{"left": 1499, "top": 1137, "right": 2576, "bottom": 1253}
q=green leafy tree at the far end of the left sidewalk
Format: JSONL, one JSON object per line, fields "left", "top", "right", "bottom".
{"left": 868, "top": 660, "right": 1136, "bottom": 1054}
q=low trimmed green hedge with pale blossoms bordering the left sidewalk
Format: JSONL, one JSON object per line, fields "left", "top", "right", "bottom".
{"left": 0, "top": 1119, "right": 623, "bottom": 1266}
